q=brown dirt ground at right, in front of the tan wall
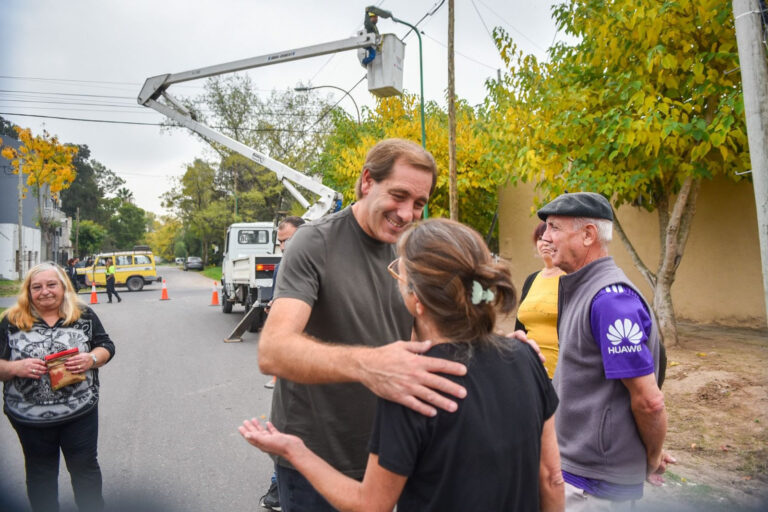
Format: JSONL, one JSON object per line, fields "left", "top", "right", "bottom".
{"left": 646, "top": 324, "right": 768, "bottom": 511}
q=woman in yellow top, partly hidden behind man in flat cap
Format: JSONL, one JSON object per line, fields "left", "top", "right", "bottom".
{"left": 516, "top": 222, "right": 565, "bottom": 379}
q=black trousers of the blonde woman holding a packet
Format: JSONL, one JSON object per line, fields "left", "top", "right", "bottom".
{"left": 11, "top": 407, "right": 104, "bottom": 512}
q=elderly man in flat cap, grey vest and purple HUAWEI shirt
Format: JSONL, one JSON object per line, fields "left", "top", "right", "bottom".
{"left": 538, "top": 192, "right": 674, "bottom": 511}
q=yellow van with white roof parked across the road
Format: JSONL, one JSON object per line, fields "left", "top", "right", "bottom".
{"left": 78, "top": 250, "right": 162, "bottom": 292}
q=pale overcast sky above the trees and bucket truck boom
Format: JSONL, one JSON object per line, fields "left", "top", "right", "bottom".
{"left": 0, "top": 0, "right": 562, "bottom": 213}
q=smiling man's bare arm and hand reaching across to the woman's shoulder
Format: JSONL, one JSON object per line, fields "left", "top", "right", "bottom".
{"left": 259, "top": 298, "right": 467, "bottom": 416}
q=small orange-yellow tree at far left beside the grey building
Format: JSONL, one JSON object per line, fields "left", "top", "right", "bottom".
{"left": 2, "top": 126, "right": 77, "bottom": 253}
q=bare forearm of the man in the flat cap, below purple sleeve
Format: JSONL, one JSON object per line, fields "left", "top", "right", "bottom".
{"left": 621, "top": 373, "right": 668, "bottom": 477}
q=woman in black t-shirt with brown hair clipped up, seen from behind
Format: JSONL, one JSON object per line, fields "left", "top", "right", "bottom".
{"left": 239, "top": 219, "right": 564, "bottom": 512}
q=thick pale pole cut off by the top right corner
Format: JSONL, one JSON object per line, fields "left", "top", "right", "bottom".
{"left": 733, "top": 0, "right": 768, "bottom": 318}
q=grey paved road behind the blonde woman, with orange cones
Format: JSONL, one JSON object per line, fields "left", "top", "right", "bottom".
{"left": 0, "top": 267, "right": 272, "bottom": 512}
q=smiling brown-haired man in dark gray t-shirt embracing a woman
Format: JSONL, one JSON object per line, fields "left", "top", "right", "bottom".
{"left": 259, "top": 139, "right": 466, "bottom": 512}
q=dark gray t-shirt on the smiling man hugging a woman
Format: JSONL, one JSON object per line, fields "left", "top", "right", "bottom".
{"left": 272, "top": 207, "right": 413, "bottom": 478}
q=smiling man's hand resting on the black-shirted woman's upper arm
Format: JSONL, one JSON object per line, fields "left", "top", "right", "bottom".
{"left": 358, "top": 341, "right": 467, "bottom": 416}
